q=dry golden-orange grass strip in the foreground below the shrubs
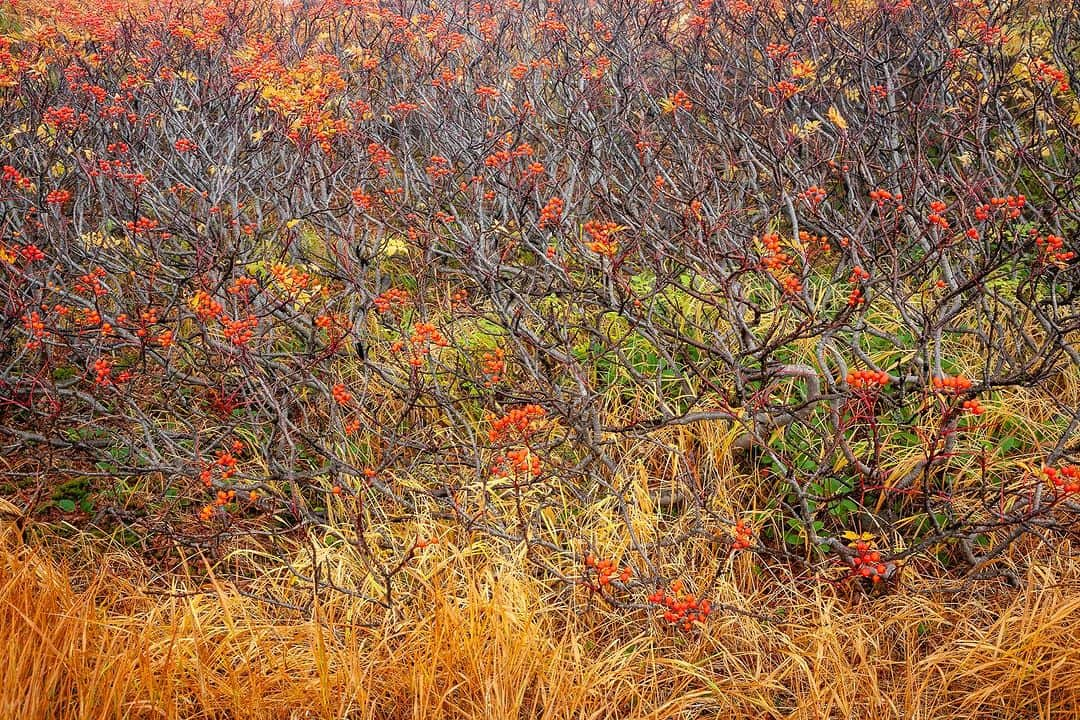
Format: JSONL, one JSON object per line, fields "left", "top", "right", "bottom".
{"left": 6, "top": 524, "right": 1080, "bottom": 720}
